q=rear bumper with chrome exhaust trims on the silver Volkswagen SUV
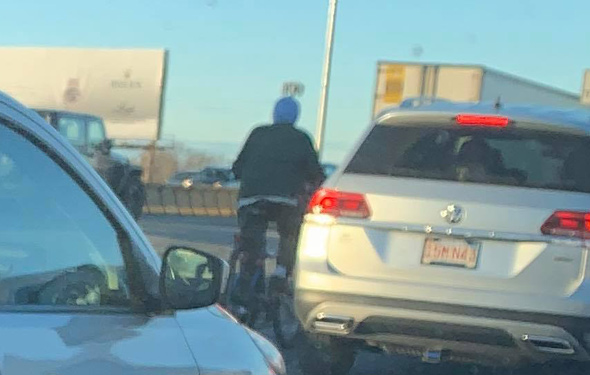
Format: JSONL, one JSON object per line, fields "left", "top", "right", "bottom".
{"left": 296, "top": 289, "right": 590, "bottom": 366}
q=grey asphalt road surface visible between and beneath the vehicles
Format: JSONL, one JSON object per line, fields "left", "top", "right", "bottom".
{"left": 140, "top": 215, "right": 544, "bottom": 375}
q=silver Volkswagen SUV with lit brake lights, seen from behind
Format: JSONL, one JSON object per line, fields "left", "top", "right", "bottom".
{"left": 296, "top": 102, "right": 590, "bottom": 373}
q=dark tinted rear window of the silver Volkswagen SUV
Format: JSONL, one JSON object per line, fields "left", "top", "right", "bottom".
{"left": 345, "top": 125, "right": 590, "bottom": 193}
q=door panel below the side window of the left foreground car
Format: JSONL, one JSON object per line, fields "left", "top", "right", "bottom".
{"left": 0, "top": 310, "right": 201, "bottom": 375}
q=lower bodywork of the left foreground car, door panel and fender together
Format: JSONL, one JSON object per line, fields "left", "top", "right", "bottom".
{"left": 0, "top": 306, "right": 269, "bottom": 375}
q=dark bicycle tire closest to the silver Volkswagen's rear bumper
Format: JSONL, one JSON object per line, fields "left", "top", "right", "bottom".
{"left": 269, "top": 292, "right": 301, "bottom": 349}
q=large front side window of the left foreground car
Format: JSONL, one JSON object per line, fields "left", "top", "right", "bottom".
{"left": 0, "top": 125, "right": 129, "bottom": 308}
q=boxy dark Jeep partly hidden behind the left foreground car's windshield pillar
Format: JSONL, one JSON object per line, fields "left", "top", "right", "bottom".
{"left": 36, "top": 109, "right": 145, "bottom": 219}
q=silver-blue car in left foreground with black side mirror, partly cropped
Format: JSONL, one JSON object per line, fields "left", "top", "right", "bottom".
{"left": 0, "top": 95, "right": 285, "bottom": 375}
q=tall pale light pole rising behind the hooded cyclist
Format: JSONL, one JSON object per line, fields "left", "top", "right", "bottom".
{"left": 315, "top": 0, "right": 338, "bottom": 156}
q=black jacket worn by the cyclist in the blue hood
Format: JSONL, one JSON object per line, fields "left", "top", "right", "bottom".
{"left": 233, "top": 125, "right": 324, "bottom": 198}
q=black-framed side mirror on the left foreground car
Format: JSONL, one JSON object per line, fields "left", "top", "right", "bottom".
{"left": 160, "top": 246, "right": 229, "bottom": 310}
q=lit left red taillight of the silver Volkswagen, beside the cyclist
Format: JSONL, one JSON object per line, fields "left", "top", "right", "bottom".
{"left": 307, "top": 189, "right": 371, "bottom": 219}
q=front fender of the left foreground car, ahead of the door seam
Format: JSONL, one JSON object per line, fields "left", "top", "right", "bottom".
{"left": 176, "top": 306, "right": 269, "bottom": 375}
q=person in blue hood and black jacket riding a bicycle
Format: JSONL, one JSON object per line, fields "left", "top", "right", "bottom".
{"left": 232, "top": 97, "right": 324, "bottom": 304}
